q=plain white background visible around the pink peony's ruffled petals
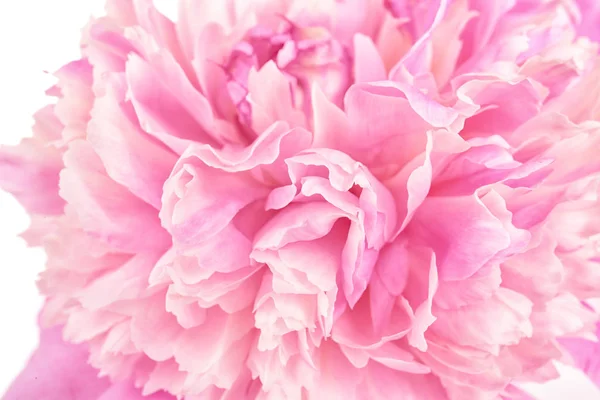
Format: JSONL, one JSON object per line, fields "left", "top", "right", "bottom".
{"left": 0, "top": 0, "right": 600, "bottom": 400}
